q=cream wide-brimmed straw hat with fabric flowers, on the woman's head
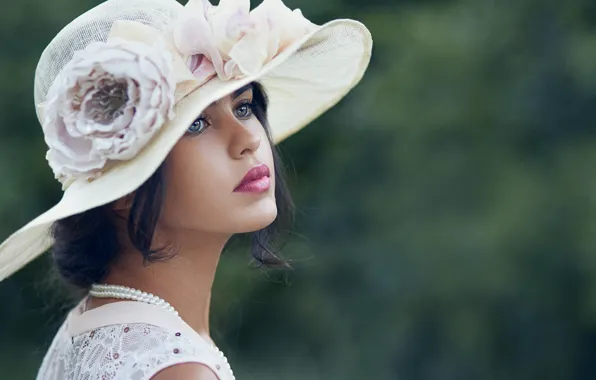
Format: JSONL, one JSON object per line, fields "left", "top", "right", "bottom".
{"left": 0, "top": 0, "right": 372, "bottom": 281}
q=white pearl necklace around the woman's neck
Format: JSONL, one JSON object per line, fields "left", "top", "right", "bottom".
{"left": 89, "top": 284, "right": 235, "bottom": 380}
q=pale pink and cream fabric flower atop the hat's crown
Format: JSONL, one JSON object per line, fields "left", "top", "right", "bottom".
{"left": 174, "top": 0, "right": 317, "bottom": 82}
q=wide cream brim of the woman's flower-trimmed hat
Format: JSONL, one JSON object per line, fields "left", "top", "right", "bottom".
{"left": 0, "top": 20, "right": 372, "bottom": 281}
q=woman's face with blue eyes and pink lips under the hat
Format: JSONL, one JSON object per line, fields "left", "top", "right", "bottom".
{"left": 159, "top": 85, "right": 277, "bottom": 234}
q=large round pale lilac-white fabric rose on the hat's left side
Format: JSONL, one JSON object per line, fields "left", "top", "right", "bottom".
{"left": 43, "top": 39, "right": 176, "bottom": 184}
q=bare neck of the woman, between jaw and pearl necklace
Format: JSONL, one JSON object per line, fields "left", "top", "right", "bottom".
{"left": 92, "top": 232, "right": 229, "bottom": 339}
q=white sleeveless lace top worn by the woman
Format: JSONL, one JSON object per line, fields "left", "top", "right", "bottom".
{"left": 37, "top": 299, "right": 233, "bottom": 380}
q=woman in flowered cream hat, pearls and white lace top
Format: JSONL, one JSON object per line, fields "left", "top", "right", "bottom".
{"left": 0, "top": 0, "right": 372, "bottom": 380}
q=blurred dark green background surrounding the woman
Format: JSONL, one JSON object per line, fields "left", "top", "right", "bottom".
{"left": 0, "top": 0, "right": 596, "bottom": 380}
